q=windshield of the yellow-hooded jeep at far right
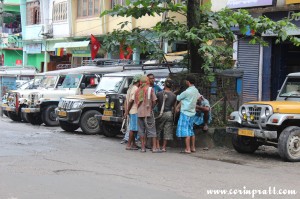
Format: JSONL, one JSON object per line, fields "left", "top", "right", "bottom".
{"left": 279, "top": 78, "right": 300, "bottom": 97}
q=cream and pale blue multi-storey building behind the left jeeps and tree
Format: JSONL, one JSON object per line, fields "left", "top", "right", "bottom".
{"left": 20, "top": 0, "right": 220, "bottom": 71}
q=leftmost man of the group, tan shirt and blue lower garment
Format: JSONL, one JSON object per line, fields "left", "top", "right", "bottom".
{"left": 124, "top": 75, "right": 142, "bottom": 150}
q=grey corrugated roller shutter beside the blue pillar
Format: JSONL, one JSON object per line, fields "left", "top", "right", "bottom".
{"left": 238, "top": 39, "right": 260, "bottom": 102}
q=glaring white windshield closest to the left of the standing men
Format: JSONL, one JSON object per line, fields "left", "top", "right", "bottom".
{"left": 95, "top": 77, "right": 124, "bottom": 93}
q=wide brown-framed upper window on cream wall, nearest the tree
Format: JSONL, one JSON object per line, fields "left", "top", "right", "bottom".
{"left": 77, "top": 0, "right": 100, "bottom": 17}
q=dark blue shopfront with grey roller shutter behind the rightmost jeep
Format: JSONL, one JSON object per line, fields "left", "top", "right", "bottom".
{"left": 227, "top": 0, "right": 300, "bottom": 102}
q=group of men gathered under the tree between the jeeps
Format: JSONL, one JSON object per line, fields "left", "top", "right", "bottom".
{"left": 124, "top": 74, "right": 210, "bottom": 153}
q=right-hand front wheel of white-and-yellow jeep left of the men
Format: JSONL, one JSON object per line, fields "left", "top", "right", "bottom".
{"left": 79, "top": 110, "right": 101, "bottom": 135}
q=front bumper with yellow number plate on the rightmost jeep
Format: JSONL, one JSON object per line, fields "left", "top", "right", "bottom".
{"left": 226, "top": 127, "right": 277, "bottom": 140}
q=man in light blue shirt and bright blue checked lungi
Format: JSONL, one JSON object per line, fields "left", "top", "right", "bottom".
{"left": 176, "top": 75, "right": 200, "bottom": 153}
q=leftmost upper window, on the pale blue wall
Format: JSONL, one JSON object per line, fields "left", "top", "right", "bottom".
{"left": 26, "top": 1, "right": 41, "bottom": 25}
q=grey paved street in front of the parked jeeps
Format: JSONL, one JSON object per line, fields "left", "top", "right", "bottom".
{"left": 0, "top": 117, "right": 300, "bottom": 199}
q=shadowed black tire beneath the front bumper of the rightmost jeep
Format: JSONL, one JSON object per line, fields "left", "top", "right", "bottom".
{"left": 232, "top": 134, "right": 259, "bottom": 153}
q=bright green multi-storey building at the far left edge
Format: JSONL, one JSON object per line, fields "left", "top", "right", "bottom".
{"left": 0, "top": 0, "right": 22, "bottom": 66}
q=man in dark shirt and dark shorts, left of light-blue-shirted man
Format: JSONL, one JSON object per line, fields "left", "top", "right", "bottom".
{"left": 155, "top": 79, "right": 176, "bottom": 152}
